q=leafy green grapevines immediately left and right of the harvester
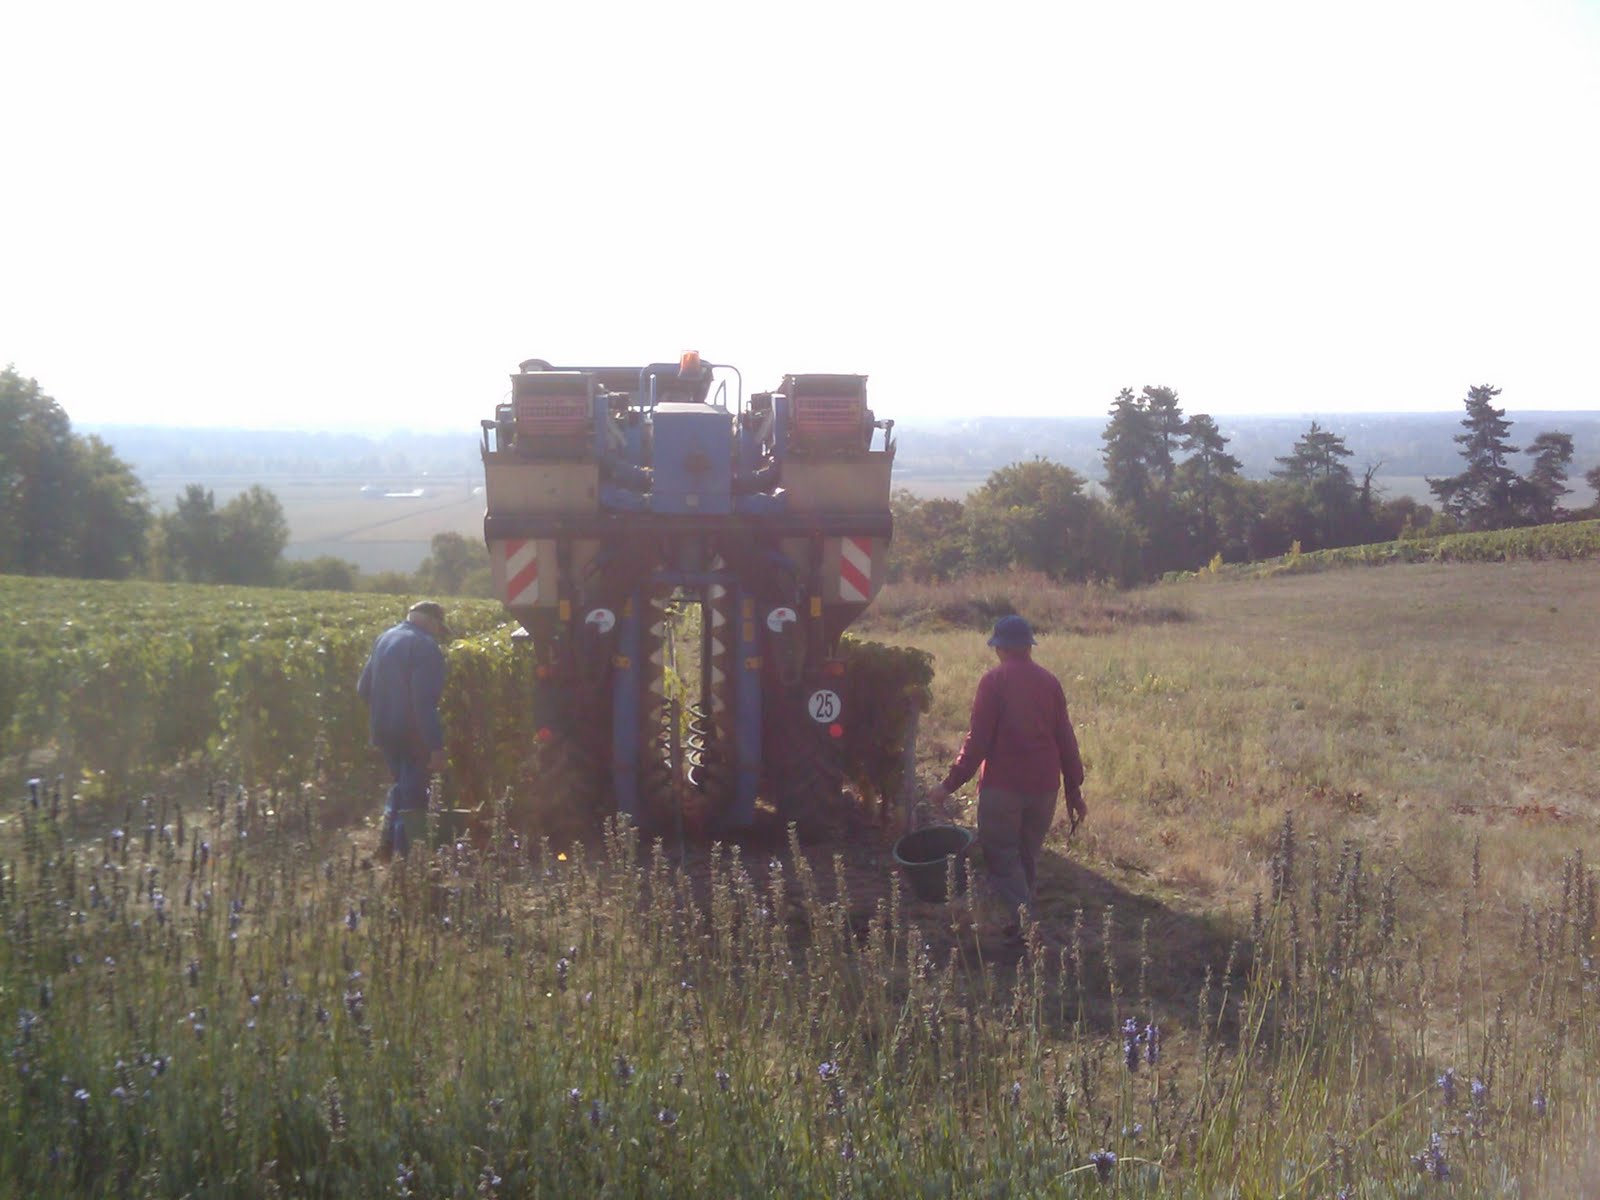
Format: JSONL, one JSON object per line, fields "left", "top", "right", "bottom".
{"left": 0, "top": 576, "right": 933, "bottom": 825}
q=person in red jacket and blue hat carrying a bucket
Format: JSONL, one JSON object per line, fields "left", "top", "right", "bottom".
{"left": 928, "top": 616, "right": 1088, "bottom": 939}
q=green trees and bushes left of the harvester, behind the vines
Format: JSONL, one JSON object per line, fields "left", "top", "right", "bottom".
{"left": 0, "top": 366, "right": 490, "bottom": 595}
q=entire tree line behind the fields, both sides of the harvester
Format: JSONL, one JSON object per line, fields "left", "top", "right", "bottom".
{"left": 0, "top": 366, "right": 1600, "bottom": 597}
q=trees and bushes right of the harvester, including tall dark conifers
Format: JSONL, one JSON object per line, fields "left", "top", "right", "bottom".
{"left": 890, "top": 384, "right": 1600, "bottom": 586}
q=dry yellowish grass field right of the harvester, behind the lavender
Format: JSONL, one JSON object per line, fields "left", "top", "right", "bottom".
{"left": 875, "top": 562, "right": 1600, "bottom": 1004}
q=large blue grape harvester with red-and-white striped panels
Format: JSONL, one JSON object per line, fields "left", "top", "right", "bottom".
{"left": 482, "top": 352, "right": 894, "bottom": 834}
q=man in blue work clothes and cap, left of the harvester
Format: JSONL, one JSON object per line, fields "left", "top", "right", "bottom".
{"left": 355, "top": 600, "right": 450, "bottom": 861}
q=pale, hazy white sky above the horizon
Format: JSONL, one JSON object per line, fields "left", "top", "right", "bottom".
{"left": 0, "top": 0, "right": 1600, "bottom": 429}
